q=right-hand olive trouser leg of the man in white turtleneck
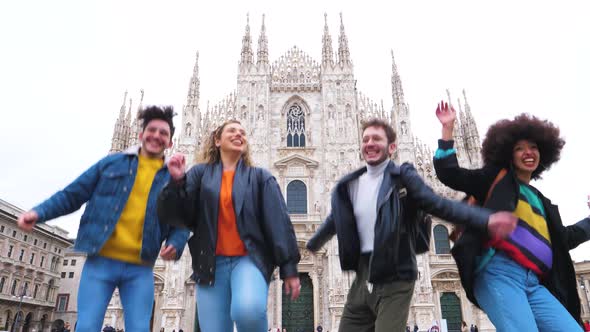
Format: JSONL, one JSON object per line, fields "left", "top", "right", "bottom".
{"left": 374, "top": 280, "right": 415, "bottom": 332}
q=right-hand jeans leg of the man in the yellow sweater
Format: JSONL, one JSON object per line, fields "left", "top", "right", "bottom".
{"left": 118, "top": 263, "right": 154, "bottom": 332}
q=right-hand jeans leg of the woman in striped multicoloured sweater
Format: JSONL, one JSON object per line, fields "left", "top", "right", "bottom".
{"left": 529, "top": 277, "right": 582, "bottom": 332}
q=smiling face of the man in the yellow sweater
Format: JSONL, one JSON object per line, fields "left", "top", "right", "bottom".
{"left": 139, "top": 119, "right": 172, "bottom": 158}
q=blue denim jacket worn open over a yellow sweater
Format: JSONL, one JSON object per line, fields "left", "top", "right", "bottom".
{"left": 33, "top": 146, "right": 189, "bottom": 264}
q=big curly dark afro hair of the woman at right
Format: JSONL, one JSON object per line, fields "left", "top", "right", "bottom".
{"left": 481, "top": 113, "right": 565, "bottom": 179}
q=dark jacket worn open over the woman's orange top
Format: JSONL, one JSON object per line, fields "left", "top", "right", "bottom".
{"left": 158, "top": 160, "right": 300, "bottom": 285}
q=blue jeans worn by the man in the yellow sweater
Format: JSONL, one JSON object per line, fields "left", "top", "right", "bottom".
{"left": 76, "top": 256, "right": 154, "bottom": 332}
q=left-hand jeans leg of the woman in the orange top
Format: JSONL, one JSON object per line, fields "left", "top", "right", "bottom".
{"left": 197, "top": 257, "right": 234, "bottom": 332}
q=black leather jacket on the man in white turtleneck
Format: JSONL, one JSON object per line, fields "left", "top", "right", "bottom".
{"left": 307, "top": 161, "right": 490, "bottom": 282}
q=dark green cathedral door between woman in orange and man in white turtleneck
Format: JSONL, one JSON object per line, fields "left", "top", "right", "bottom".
{"left": 281, "top": 273, "right": 314, "bottom": 332}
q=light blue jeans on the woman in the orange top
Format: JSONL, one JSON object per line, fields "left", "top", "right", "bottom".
{"left": 196, "top": 256, "right": 268, "bottom": 332}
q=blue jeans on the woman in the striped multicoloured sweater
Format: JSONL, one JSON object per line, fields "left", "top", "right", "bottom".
{"left": 474, "top": 252, "right": 582, "bottom": 332}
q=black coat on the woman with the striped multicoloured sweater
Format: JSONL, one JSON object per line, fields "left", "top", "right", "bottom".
{"left": 434, "top": 140, "right": 590, "bottom": 321}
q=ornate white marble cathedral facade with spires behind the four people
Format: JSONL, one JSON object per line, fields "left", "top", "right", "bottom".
{"left": 110, "top": 13, "right": 494, "bottom": 332}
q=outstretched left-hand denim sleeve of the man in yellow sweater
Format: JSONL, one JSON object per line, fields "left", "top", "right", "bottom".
{"left": 32, "top": 157, "right": 108, "bottom": 222}
